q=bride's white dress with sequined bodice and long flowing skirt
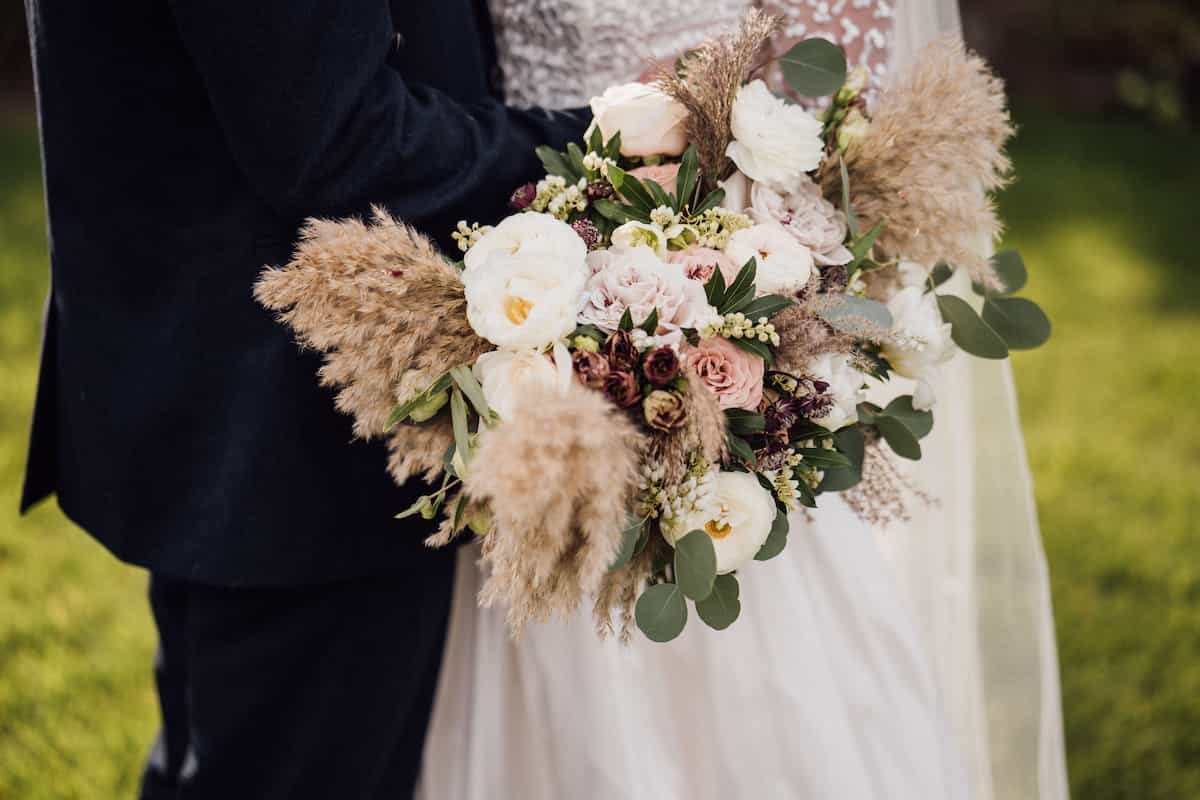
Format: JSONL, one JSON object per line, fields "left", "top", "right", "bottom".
{"left": 420, "top": 0, "right": 1065, "bottom": 800}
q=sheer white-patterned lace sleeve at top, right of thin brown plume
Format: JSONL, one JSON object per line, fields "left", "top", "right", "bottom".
{"left": 762, "top": 0, "right": 896, "bottom": 97}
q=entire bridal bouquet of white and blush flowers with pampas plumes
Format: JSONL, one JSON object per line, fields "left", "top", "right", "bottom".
{"left": 256, "top": 12, "right": 1049, "bottom": 642}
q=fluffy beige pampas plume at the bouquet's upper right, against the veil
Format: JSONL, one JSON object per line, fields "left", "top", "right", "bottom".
{"left": 821, "top": 37, "right": 1013, "bottom": 287}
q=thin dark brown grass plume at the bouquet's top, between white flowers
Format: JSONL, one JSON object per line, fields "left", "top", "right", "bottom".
{"left": 655, "top": 8, "right": 780, "bottom": 190}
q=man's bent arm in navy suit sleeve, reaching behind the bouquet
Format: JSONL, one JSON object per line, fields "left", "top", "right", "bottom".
{"left": 172, "top": 0, "right": 587, "bottom": 219}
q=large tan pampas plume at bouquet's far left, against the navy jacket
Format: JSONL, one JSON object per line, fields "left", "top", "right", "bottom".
{"left": 254, "top": 209, "right": 492, "bottom": 483}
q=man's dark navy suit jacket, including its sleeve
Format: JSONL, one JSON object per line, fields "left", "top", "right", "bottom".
{"left": 22, "top": 0, "right": 586, "bottom": 585}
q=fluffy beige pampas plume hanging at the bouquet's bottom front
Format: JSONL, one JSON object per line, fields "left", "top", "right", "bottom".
{"left": 463, "top": 383, "right": 643, "bottom": 636}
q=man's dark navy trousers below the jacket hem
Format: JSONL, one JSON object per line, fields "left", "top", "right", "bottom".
{"left": 140, "top": 551, "right": 454, "bottom": 800}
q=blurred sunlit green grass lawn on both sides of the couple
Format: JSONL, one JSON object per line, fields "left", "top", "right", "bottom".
{"left": 0, "top": 112, "right": 1200, "bottom": 800}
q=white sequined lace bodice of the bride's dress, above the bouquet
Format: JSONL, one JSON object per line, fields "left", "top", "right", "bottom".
{"left": 490, "top": 0, "right": 902, "bottom": 108}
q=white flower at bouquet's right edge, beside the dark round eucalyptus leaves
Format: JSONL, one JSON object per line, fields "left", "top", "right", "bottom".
{"left": 882, "top": 287, "right": 955, "bottom": 410}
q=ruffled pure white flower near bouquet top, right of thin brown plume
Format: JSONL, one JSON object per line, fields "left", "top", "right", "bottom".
{"left": 725, "top": 80, "right": 824, "bottom": 192}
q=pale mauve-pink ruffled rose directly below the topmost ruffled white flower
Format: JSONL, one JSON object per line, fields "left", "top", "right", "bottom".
{"left": 749, "top": 175, "right": 854, "bottom": 265}
